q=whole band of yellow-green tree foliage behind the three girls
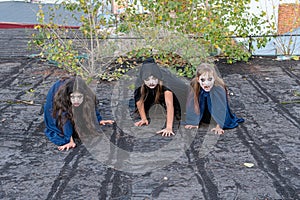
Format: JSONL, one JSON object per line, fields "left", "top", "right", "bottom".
{"left": 33, "top": 0, "right": 272, "bottom": 80}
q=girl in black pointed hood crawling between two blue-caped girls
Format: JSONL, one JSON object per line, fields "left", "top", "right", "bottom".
{"left": 134, "top": 57, "right": 181, "bottom": 136}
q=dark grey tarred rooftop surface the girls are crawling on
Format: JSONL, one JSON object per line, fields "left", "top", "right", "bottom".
{"left": 0, "top": 30, "right": 300, "bottom": 200}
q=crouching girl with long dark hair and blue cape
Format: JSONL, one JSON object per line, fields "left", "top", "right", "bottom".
{"left": 44, "top": 77, "right": 113, "bottom": 151}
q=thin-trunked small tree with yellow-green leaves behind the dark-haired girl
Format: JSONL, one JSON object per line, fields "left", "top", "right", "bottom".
{"left": 32, "top": 0, "right": 114, "bottom": 78}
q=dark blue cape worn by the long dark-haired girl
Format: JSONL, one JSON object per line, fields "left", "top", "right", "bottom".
{"left": 44, "top": 79, "right": 102, "bottom": 146}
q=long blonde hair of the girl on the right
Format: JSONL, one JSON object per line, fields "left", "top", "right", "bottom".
{"left": 190, "top": 63, "right": 227, "bottom": 114}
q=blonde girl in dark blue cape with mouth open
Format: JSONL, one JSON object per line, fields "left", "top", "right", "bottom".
{"left": 185, "top": 63, "right": 244, "bottom": 134}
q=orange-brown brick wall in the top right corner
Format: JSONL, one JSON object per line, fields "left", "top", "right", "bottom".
{"left": 278, "top": 3, "right": 300, "bottom": 34}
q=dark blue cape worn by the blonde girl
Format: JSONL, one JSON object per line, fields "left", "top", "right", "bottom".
{"left": 186, "top": 86, "right": 244, "bottom": 129}
